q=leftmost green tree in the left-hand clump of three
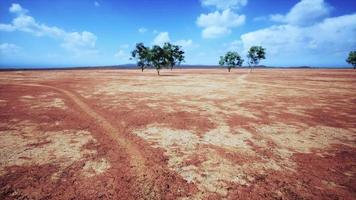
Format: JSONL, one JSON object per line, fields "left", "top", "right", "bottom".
{"left": 131, "top": 43, "right": 152, "bottom": 71}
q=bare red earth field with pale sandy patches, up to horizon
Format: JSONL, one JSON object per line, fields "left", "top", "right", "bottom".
{"left": 0, "top": 69, "right": 356, "bottom": 200}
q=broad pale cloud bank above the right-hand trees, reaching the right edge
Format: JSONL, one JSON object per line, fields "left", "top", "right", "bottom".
{"left": 241, "top": 13, "right": 356, "bottom": 62}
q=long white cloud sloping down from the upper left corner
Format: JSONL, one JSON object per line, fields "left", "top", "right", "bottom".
{"left": 0, "top": 4, "right": 97, "bottom": 56}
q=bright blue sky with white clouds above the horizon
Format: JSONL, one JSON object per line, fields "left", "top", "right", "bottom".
{"left": 0, "top": 0, "right": 356, "bottom": 67}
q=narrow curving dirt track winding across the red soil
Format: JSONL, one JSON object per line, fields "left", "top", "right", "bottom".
{"left": 15, "top": 83, "right": 161, "bottom": 199}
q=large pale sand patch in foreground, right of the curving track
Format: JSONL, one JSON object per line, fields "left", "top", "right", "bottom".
{"left": 134, "top": 124, "right": 281, "bottom": 199}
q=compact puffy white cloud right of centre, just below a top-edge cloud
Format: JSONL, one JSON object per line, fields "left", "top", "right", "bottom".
{"left": 196, "top": 9, "right": 246, "bottom": 38}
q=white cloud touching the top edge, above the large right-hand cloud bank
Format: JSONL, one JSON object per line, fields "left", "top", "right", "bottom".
{"left": 270, "top": 0, "right": 331, "bottom": 25}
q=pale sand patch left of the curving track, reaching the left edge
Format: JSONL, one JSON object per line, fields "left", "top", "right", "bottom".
{"left": 0, "top": 121, "right": 109, "bottom": 175}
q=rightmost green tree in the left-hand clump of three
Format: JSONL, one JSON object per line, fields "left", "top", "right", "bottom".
{"left": 163, "top": 42, "right": 184, "bottom": 70}
